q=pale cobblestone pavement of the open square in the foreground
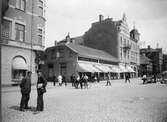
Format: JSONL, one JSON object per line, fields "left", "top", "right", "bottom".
{"left": 2, "top": 79, "right": 167, "bottom": 122}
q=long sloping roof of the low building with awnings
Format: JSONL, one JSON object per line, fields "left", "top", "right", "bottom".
{"left": 66, "top": 43, "right": 119, "bottom": 62}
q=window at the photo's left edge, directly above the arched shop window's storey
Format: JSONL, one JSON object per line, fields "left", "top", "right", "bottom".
{"left": 1, "top": 20, "right": 12, "bottom": 39}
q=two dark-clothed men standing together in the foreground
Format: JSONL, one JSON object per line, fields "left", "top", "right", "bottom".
{"left": 20, "top": 71, "right": 47, "bottom": 111}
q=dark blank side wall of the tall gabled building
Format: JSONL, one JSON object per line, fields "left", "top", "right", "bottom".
{"left": 84, "top": 23, "right": 118, "bottom": 58}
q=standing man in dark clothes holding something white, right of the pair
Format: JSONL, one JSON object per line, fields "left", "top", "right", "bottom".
{"left": 36, "top": 71, "right": 47, "bottom": 111}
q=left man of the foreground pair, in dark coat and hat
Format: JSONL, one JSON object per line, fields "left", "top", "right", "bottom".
{"left": 20, "top": 71, "right": 31, "bottom": 111}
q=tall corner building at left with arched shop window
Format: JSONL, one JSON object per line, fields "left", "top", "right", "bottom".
{"left": 1, "top": 0, "right": 46, "bottom": 84}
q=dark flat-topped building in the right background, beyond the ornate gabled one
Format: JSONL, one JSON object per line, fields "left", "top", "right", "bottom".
{"left": 140, "top": 46, "right": 163, "bottom": 74}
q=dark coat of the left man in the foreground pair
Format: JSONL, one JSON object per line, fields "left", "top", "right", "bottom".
{"left": 20, "top": 77, "right": 31, "bottom": 94}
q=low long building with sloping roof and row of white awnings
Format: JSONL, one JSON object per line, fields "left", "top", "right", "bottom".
{"left": 44, "top": 43, "right": 120, "bottom": 81}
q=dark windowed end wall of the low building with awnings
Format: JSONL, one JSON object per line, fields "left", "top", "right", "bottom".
{"left": 44, "top": 46, "right": 77, "bottom": 80}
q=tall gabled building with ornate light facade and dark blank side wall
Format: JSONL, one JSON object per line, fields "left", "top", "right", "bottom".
{"left": 84, "top": 14, "right": 140, "bottom": 78}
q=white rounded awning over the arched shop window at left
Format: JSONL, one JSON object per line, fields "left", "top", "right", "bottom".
{"left": 12, "top": 57, "right": 28, "bottom": 70}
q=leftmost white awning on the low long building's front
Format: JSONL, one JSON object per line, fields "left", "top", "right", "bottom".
{"left": 76, "top": 62, "right": 101, "bottom": 72}
